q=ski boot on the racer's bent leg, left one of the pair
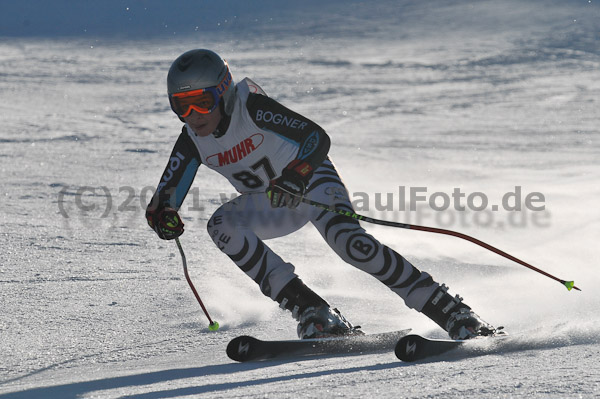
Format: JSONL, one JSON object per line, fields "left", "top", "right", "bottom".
{"left": 275, "top": 277, "right": 364, "bottom": 339}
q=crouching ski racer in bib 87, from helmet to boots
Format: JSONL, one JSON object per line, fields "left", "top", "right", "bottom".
{"left": 146, "top": 49, "right": 495, "bottom": 339}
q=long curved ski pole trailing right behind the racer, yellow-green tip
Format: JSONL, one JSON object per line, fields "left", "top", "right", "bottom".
{"left": 301, "top": 197, "right": 581, "bottom": 291}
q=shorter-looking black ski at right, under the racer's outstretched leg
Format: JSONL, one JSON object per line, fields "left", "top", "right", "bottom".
{"left": 394, "top": 332, "right": 508, "bottom": 362}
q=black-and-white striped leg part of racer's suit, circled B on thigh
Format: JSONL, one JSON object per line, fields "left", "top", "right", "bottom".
{"left": 208, "top": 160, "right": 438, "bottom": 310}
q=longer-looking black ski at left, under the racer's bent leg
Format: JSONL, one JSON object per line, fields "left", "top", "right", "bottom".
{"left": 227, "top": 329, "right": 410, "bottom": 362}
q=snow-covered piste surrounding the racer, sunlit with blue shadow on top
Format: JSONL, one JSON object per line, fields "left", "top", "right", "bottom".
{"left": 0, "top": 0, "right": 600, "bottom": 399}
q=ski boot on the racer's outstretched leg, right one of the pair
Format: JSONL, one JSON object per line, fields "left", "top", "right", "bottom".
{"left": 421, "top": 284, "right": 502, "bottom": 340}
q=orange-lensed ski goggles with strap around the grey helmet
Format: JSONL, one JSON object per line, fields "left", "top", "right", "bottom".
{"left": 169, "top": 68, "right": 233, "bottom": 118}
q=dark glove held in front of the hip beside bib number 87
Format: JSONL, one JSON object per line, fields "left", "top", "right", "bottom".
{"left": 267, "top": 159, "right": 313, "bottom": 209}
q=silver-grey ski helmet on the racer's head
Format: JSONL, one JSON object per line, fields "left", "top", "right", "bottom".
{"left": 167, "top": 49, "right": 236, "bottom": 118}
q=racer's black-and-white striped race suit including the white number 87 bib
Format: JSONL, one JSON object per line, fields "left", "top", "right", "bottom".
{"left": 150, "top": 79, "right": 438, "bottom": 316}
